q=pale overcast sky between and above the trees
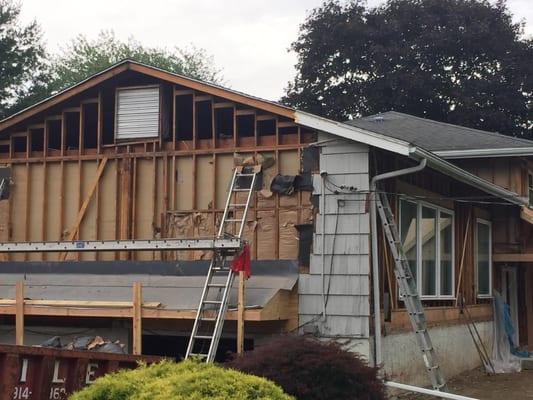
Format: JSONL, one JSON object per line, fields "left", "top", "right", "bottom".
{"left": 18, "top": 0, "right": 533, "bottom": 100}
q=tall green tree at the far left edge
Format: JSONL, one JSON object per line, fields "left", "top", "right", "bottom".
{"left": 0, "top": 0, "right": 46, "bottom": 119}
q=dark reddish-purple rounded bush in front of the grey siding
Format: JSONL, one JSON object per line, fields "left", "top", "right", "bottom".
{"left": 225, "top": 335, "right": 386, "bottom": 400}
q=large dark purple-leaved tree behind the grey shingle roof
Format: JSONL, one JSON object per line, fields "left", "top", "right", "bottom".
{"left": 283, "top": 0, "right": 533, "bottom": 137}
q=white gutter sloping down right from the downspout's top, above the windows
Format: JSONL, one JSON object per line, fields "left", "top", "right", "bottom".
{"left": 411, "top": 147, "right": 528, "bottom": 206}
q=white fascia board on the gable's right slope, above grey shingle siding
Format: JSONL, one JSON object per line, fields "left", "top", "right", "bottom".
{"left": 294, "top": 111, "right": 412, "bottom": 156}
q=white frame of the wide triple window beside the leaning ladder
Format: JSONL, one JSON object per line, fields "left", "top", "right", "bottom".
{"left": 398, "top": 195, "right": 456, "bottom": 300}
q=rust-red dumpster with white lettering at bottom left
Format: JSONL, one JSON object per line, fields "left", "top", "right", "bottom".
{"left": 0, "top": 345, "right": 163, "bottom": 400}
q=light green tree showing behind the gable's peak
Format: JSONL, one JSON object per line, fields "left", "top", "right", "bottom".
{"left": 6, "top": 30, "right": 222, "bottom": 117}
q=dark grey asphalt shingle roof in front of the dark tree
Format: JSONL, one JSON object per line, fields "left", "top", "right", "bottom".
{"left": 345, "top": 111, "right": 533, "bottom": 152}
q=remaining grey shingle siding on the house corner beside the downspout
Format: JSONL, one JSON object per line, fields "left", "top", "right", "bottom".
{"left": 299, "top": 137, "right": 370, "bottom": 339}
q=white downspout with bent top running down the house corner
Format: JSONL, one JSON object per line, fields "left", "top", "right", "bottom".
{"left": 370, "top": 158, "right": 427, "bottom": 366}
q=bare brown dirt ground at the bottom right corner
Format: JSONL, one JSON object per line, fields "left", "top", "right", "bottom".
{"left": 397, "top": 368, "right": 533, "bottom": 400}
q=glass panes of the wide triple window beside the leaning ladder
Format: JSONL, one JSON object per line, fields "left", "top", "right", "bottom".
{"left": 400, "top": 199, "right": 454, "bottom": 298}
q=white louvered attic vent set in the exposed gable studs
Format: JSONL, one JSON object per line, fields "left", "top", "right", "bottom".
{"left": 115, "top": 86, "right": 160, "bottom": 140}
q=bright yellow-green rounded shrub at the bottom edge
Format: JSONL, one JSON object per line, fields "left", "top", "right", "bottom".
{"left": 70, "top": 361, "right": 292, "bottom": 400}
